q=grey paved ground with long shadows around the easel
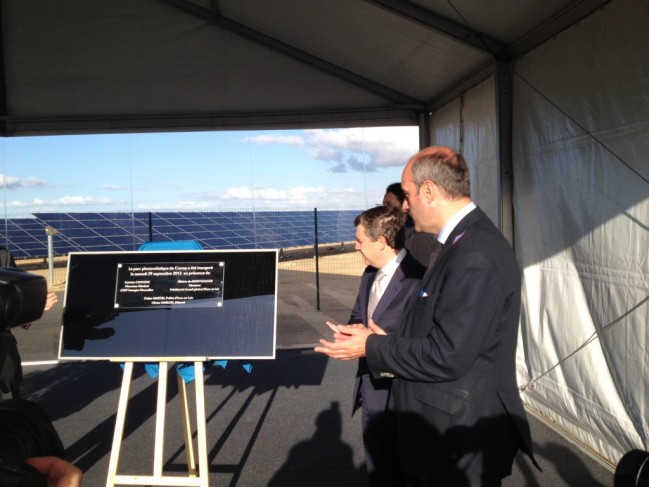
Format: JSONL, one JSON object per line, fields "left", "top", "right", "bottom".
{"left": 8, "top": 258, "right": 613, "bottom": 487}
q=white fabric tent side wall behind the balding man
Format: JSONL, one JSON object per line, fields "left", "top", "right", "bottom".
{"left": 431, "top": 0, "right": 649, "bottom": 467}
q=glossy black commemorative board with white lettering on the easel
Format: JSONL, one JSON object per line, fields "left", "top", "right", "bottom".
{"left": 59, "top": 250, "right": 278, "bottom": 361}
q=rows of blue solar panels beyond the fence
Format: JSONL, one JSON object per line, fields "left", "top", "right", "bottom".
{"left": 0, "top": 209, "right": 361, "bottom": 258}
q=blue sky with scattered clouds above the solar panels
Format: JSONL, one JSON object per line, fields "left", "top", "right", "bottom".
{"left": 0, "top": 127, "right": 418, "bottom": 216}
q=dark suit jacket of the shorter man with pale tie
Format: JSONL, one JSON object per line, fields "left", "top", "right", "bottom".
{"left": 348, "top": 254, "right": 426, "bottom": 411}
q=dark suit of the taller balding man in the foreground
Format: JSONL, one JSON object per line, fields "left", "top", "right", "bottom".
{"left": 366, "top": 208, "right": 536, "bottom": 487}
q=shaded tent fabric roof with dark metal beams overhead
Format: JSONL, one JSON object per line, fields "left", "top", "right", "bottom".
{"left": 0, "top": 0, "right": 607, "bottom": 136}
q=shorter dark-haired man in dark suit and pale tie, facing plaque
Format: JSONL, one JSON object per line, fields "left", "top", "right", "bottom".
{"left": 340, "top": 206, "right": 425, "bottom": 487}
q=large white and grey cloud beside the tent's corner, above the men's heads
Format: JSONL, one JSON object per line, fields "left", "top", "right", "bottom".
{"left": 247, "top": 127, "right": 419, "bottom": 172}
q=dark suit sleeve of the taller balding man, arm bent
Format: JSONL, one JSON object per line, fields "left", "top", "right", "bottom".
{"left": 366, "top": 252, "right": 506, "bottom": 382}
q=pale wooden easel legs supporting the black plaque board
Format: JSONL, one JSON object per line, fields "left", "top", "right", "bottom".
{"left": 106, "top": 362, "right": 209, "bottom": 487}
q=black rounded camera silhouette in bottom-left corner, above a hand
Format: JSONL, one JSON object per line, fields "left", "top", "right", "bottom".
{"left": 0, "top": 399, "right": 64, "bottom": 487}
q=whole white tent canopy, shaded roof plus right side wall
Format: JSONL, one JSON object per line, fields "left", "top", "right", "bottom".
{"left": 0, "top": 0, "right": 649, "bottom": 472}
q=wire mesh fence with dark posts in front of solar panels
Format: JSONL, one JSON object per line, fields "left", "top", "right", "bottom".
{"left": 5, "top": 208, "right": 364, "bottom": 316}
